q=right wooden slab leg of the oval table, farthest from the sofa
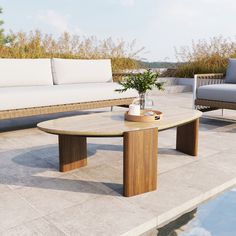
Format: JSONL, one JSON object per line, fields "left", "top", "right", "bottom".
{"left": 176, "top": 119, "right": 199, "bottom": 156}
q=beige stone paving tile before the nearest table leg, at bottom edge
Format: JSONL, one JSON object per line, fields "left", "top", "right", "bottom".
{"left": 45, "top": 196, "right": 157, "bottom": 236}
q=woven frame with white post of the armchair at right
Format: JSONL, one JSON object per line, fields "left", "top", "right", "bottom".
{"left": 193, "top": 73, "right": 236, "bottom": 111}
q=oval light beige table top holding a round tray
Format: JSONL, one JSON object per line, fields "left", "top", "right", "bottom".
{"left": 37, "top": 108, "right": 202, "bottom": 137}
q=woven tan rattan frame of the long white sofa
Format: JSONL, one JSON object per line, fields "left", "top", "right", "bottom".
{"left": 0, "top": 73, "right": 134, "bottom": 120}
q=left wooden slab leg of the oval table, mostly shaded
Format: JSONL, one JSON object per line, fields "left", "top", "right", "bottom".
{"left": 59, "top": 135, "right": 87, "bottom": 172}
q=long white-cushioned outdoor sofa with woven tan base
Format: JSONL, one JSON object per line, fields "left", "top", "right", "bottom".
{"left": 0, "top": 59, "right": 138, "bottom": 119}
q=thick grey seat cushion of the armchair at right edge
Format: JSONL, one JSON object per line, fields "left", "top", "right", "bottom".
{"left": 197, "top": 84, "right": 236, "bottom": 102}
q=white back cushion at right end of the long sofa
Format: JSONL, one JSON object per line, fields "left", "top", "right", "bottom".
{"left": 52, "top": 58, "right": 112, "bottom": 85}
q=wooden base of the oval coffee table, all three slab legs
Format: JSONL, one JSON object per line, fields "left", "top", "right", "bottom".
{"left": 59, "top": 119, "right": 199, "bottom": 197}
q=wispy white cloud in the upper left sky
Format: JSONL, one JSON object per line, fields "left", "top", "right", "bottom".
{"left": 37, "top": 10, "right": 83, "bottom": 34}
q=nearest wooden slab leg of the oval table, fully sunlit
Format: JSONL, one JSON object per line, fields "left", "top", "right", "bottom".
{"left": 123, "top": 128, "right": 158, "bottom": 197}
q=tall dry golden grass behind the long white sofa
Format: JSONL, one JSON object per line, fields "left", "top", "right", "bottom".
{"left": 0, "top": 31, "right": 143, "bottom": 72}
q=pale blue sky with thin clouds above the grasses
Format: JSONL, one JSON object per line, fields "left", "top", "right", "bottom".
{"left": 0, "top": 0, "right": 236, "bottom": 61}
